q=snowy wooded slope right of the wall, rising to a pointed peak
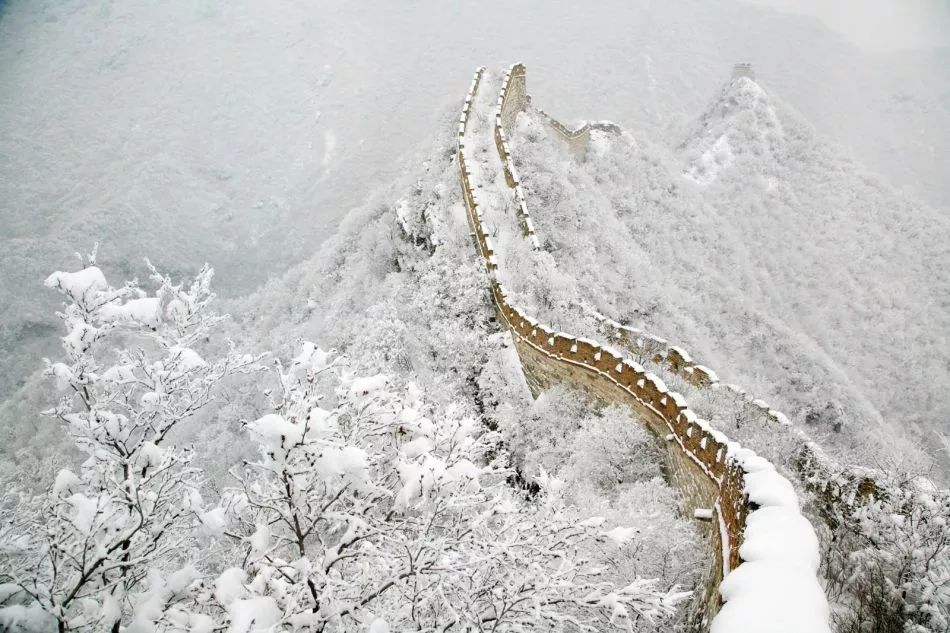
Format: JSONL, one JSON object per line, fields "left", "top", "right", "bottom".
{"left": 512, "top": 78, "right": 950, "bottom": 462}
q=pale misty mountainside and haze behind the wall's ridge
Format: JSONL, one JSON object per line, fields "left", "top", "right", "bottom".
{"left": 0, "top": 0, "right": 950, "bottom": 404}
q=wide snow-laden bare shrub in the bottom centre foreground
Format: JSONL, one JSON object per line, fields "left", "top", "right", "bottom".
{"left": 216, "top": 348, "right": 686, "bottom": 631}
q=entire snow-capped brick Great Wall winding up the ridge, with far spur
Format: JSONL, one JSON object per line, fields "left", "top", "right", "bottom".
{"left": 457, "top": 64, "right": 828, "bottom": 633}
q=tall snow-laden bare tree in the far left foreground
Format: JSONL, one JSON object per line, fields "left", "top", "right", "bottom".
{"left": 4, "top": 253, "right": 257, "bottom": 631}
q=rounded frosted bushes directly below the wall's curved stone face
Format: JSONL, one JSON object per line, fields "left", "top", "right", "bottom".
{"left": 483, "top": 380, "right": 707, "bottom": 616}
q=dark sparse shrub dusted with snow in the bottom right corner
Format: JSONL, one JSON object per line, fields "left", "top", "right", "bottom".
{"left": 823, "top": 470, "right": 950, "bottom": 633}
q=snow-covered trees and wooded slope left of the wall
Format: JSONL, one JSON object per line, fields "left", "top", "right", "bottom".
{"left": 0, "top": 141, "right": 704, "bottom": 631}
